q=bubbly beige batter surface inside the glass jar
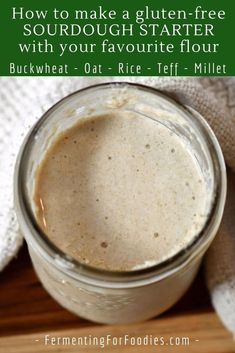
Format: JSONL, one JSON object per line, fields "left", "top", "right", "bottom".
{"left": 34, "top": 111, "right": 207, "bottom": 271}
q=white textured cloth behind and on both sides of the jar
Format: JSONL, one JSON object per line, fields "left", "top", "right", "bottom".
{"left": 0, "top": 77, "right": 235, "bottom": 333}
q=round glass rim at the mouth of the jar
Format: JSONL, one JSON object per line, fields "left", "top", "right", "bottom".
{"left": 14, "top": 81, "right": 226, "bottom": 283}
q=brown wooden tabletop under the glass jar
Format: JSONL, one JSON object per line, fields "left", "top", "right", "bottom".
{"left": 0, "top": 245, "right": 235, "bottom": 353}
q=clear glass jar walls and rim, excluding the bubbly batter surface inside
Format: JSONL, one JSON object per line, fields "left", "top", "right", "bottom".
{"left": 14, "top": 83, "right": 226, "bottom": 324}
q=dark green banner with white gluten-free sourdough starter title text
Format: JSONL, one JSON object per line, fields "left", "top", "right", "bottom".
{"left": 0, "top": 0, "right": 235, "bottom": 76}
